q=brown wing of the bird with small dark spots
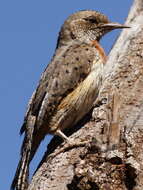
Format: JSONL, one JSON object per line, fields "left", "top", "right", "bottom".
{"left": 21, "top": 43, "right": 95, "bottom": 132}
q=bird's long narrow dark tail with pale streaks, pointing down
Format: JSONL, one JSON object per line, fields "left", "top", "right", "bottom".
{"left": 11, "top": 116, "right": 36, "bottom": 190}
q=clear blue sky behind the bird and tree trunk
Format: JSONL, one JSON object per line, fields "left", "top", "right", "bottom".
{"left": 0, "top": 0, "right": 132, "bottom": 190}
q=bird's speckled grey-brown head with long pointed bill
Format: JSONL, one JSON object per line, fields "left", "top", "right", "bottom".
{"left": 58, "top": 10, "right": 129, "bottom": 46}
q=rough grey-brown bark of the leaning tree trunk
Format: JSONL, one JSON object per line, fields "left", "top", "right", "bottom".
{"left": 28, "top": 0, "right": 143, "bottom": 190}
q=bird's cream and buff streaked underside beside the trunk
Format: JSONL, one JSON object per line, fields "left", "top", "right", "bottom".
{"left": 48, "top": 59, "right": 103, "bottom": 130}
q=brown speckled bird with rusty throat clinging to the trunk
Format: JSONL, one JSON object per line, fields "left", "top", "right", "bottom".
{"left": 11, "top": 10, "right": 128, "bottom": 190}
